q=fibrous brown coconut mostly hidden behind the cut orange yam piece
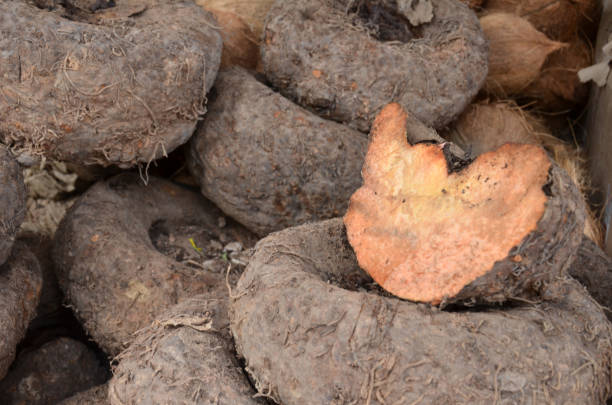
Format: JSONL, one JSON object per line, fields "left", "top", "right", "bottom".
{"left": 442, "top": 101, "right": 603, "bottom": 246}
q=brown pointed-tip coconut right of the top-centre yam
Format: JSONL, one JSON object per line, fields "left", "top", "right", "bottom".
{"left": 480, "top": 13, "right": 564, "bottom": 98}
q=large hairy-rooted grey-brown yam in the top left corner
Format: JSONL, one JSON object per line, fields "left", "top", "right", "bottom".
{"left": 0, "top": 0, "right": 222, "bottom": 167}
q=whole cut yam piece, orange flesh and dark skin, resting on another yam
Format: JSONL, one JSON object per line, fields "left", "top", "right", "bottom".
{"left": 344, "top": 104, "right": 586, "bottom": 305}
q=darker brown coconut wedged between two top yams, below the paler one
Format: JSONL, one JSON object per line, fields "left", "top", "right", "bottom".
{"left": 203, "top": 5, "right": 259, "bottom": 69}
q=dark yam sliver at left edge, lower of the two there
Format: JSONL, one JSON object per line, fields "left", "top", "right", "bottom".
{"left": 0, "top": 241, "right": 42, "bottom": 379}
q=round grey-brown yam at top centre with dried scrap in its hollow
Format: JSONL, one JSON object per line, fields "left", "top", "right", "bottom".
{"left": 261, "top": 0, "right": 488, "bottom": 132}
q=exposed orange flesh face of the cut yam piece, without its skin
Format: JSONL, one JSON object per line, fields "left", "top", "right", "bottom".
{"left": 344, "top": 104, "right": 551, "bottom": 305}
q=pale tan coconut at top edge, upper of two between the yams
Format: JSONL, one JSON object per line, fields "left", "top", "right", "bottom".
{"left": 196, "top": 0, "right": 275, "bottom": 41}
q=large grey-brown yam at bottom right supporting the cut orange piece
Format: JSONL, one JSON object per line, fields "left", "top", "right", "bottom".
{"left": 230, "top": 219, "right": 612, "bottom": 405}
